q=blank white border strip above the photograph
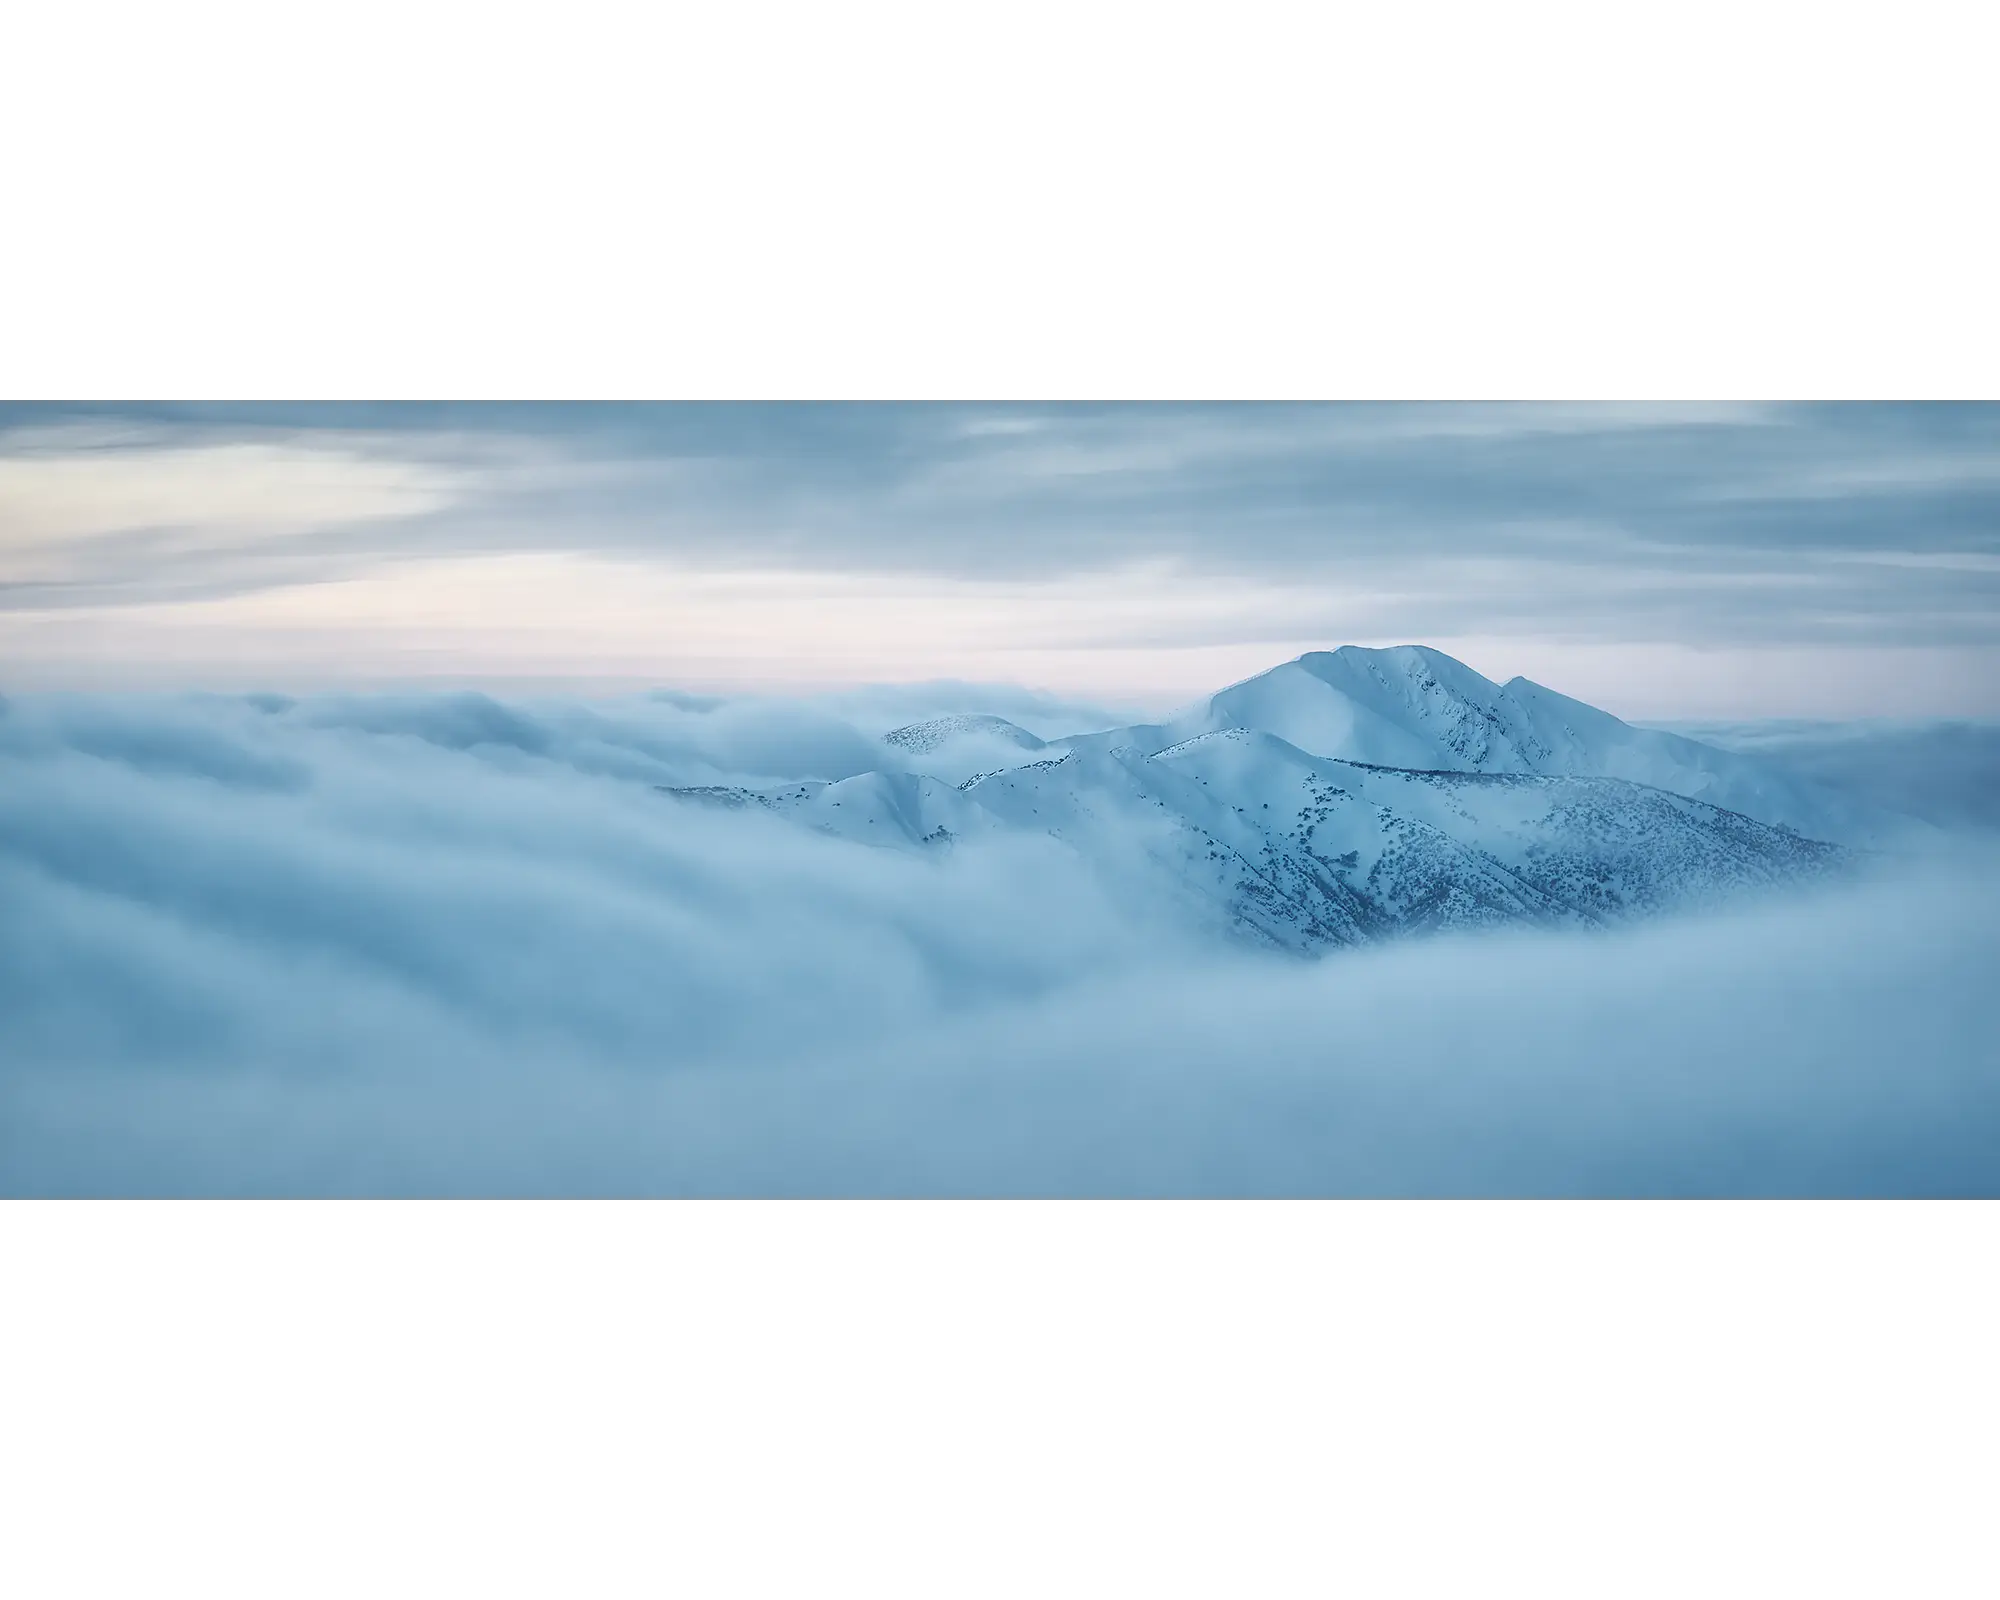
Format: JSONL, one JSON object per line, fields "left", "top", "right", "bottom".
{"left": 0, "top": 0, "right": 2000, "bottom": 398}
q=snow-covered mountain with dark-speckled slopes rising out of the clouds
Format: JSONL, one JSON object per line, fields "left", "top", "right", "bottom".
{"left": 668, "top": 646, "right": 1856, "bottom": 952}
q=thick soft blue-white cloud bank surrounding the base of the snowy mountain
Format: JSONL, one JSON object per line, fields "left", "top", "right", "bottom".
{"left": 0, "top": 692, "right": 2000, "bottom": 1196}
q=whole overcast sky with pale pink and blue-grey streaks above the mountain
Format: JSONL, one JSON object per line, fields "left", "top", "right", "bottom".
{"left": 0, "top": 404, "right": 2000, "bottom": 718}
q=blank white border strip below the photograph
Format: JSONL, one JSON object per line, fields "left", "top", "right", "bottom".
{"left": 0, "top": 1204, "right": 2000, "bottom": 1600}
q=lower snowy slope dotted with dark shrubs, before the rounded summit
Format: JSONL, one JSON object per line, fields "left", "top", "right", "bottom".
{"left": 968, "top": 730, "right": 1840, "bottom": 948}
